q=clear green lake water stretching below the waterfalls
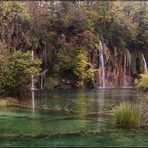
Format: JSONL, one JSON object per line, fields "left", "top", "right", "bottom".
{"left": 0, "top": 89, "right": 148, "bottom": 147}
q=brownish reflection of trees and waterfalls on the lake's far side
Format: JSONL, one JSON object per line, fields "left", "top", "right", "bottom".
{"left": 20, "top": 89, "right": 136, "bottom": 120}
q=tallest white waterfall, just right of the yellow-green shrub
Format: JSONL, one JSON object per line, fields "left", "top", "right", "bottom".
{"left": 99, "top": 40, "right": 105, "bottom": 88}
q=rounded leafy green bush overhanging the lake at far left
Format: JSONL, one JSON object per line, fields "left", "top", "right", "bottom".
{"left": 0, "top": 51, "right": 40, "bottom": 95}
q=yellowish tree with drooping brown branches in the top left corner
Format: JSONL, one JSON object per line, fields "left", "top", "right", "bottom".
{"left": 0, "top": 1, "right": 32, "bottom": 51}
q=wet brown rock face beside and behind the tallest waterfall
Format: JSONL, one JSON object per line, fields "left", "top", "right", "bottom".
{"left": 92, "top": 43, "right": 134, "bottom": 88}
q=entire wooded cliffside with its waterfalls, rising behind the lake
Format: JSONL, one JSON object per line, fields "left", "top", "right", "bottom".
{"left": 0, "top": 0, "right": 148, "bottom": 95}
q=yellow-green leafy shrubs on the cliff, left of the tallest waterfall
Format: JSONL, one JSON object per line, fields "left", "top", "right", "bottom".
{"left": 54, "top": 49, "right": 95, "bottom": 87}
